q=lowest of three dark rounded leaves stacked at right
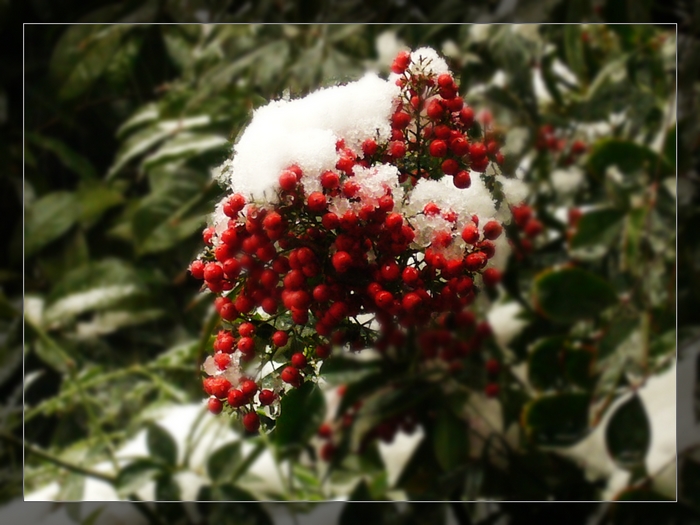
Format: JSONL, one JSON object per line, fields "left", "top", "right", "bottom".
{"left": 522, "top": 393, "right": 590, "bottom": 446}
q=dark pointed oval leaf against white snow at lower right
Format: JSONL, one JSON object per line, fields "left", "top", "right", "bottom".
{"left": 605, "top": 395, "right": 651, "bottom": 469}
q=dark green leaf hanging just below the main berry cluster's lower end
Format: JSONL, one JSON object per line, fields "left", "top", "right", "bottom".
{"left": 275, "top": 381, "right": 326, "bottom": 447}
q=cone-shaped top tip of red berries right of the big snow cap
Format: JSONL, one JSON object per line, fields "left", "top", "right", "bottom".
{"left": 392, "top": 52, "right": 504, "bottom": 189}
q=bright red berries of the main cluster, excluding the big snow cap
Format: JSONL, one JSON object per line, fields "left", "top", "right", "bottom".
{"left": 190, "top": 50, "right": 516, "bottom": 434}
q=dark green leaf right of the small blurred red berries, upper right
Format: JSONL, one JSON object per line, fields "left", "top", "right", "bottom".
{"left": 588, "top": 139, "right": 673, "bottom": 179}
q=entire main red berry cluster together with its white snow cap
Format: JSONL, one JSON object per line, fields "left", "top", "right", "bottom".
{"left": 190, "top": 48, "right": 524, "bottom": 426}
